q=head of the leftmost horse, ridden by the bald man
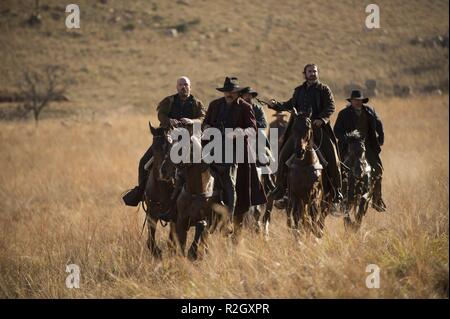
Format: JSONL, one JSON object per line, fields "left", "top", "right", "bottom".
{"left": 149, "top": 123, "right": 175, "bottom": 181}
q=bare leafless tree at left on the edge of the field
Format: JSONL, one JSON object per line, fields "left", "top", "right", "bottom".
{"left": 18, "top": 65, "right": 69, "bottom": 125}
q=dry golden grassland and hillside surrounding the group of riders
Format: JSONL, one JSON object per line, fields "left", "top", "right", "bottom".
{"left": 0, "top": 0, "right": 449, "bottom": 298}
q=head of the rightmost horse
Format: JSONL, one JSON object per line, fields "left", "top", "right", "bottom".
{"left": 345, "top": 130, "right": 366, "bottom": 178}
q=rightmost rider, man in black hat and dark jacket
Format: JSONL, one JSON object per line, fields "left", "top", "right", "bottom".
{"left": 334, "top": 90, "right": 386, "bottom": 212}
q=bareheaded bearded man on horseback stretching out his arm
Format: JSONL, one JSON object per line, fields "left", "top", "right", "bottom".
{"left": 271, "top": 64, "right": 342, "bottom": 204}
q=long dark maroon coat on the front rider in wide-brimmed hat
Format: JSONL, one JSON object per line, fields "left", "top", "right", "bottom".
{"left": 203, "top": 98, "right": 267, "bottom": 214}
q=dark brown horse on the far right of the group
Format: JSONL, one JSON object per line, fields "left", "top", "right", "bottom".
{"left": 342, "top": 130, "right": 373, "bottom": 230}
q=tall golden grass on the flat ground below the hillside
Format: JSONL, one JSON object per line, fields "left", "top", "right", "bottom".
{"left": 0, "top": 96, "right": 449, "bottom": 298}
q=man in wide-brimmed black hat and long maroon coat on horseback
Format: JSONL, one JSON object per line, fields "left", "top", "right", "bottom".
{"left": 203, "top": 77, "right": 266, "bottom": 231}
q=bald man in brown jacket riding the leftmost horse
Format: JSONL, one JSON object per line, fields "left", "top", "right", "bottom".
{"left": 123, "top": 76, "right": 206, "bottom": 206}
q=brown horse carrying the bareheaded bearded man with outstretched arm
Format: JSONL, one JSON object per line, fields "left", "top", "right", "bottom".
{"left": 287, "top": 109, "right": 326, "bottom": 238}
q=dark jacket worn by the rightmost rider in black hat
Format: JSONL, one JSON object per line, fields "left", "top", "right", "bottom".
{"left": 334, "top": 104, "right": 384, "bottom": 154}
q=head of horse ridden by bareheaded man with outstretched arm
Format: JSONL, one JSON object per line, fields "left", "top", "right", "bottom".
{"left": 292, "top": 108, "right": 313, "bottom": 160}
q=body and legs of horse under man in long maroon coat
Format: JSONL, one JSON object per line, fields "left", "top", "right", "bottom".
{"left": 161, "top": 132, "right": 227, "bottom": 260}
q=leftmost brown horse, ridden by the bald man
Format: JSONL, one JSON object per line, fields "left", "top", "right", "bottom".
{"left": 144, "top": 124, "right": 175, "bottom": 258}
